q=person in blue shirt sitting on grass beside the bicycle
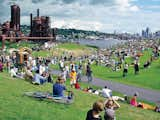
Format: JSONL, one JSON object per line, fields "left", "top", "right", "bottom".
{"left": 53, "top": 76, "right": 66, "bottom": 97}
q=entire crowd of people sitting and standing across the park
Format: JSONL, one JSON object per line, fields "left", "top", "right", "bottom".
{"left": 0, "top": 41, "right": 159, "bottom": 120}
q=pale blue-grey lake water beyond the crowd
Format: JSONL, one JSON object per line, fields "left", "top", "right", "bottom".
{"left": 79, "top": 38, "right": 125, "bottom": 48}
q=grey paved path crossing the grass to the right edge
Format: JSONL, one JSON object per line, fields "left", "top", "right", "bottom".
{"left": 52, "top": 70, "right": 160, "bottom": 105}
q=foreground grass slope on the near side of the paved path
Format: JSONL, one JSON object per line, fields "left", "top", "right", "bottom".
{"left": 0, "top": 73, "right": 160, "bottom": 120}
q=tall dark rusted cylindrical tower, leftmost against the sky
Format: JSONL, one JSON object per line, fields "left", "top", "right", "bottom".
{"left": 10, "top": 5, "right": 20, "bottom": 31}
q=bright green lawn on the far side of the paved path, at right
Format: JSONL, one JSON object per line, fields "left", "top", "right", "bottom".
{"left": 92, "top": 51, "right": 160, "bottom": 90}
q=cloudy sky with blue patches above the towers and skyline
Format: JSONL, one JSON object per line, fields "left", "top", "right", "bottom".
{"left": 0, "top": 0, "right": 160, "bottom": 33}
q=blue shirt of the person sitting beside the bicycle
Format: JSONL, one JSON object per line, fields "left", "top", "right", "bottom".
{"left": 53, "top": 83, "right": 66, "bottom": 97}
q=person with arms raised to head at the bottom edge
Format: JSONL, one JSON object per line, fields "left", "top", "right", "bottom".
{"left": 104, "top": 98, "right": 120, "bottom": 120}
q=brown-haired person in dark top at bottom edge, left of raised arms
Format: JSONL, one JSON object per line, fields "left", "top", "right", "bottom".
{"left": 86, "top": 100, "right": 104, "bottom": 120}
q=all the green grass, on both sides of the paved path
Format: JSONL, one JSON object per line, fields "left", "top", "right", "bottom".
{"left": 0, "top": 41, "right": 160, "bottom": 120}
